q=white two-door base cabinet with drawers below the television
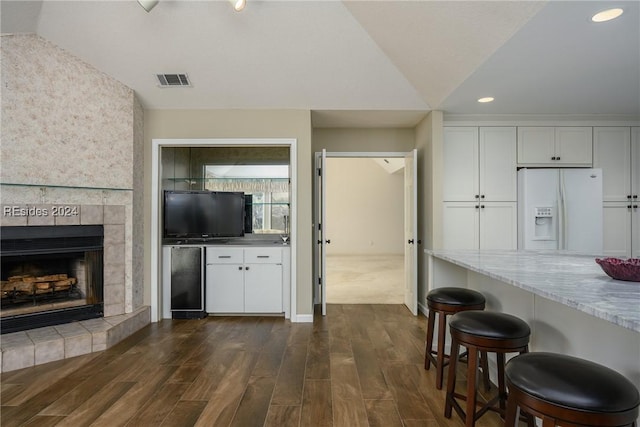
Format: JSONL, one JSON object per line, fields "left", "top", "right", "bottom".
{"left": 205, "top": 247, "right": 284, "bottom": 313}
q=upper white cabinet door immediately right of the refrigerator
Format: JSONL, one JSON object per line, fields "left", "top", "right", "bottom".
{"left": 593, "top": 127, "right": 632, "bottom": 202}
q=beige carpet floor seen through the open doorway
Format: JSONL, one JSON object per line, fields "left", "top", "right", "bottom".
{"left": 327, "top": 255, "right": 404, "bottom": 304}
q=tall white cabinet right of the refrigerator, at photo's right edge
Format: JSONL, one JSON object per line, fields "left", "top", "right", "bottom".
{"left": 593, "top": 127, "right": 640, "bottom": 258}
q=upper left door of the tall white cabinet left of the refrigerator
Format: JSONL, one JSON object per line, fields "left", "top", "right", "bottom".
{"left": 442, "top": 127, "right": 479, "bottom": 201}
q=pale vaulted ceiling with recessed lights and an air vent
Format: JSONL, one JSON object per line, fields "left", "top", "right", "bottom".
{"left": 0, "top": 0, "right": 640, "bottom": 126}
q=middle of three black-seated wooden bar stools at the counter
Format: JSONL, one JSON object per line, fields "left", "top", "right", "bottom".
{"left": 444, "top": 311, "right": 531, "bottom": 427}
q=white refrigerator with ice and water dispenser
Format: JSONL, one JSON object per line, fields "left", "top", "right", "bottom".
{"left": 518, "top": 168, "right": 603, "bottom": 255}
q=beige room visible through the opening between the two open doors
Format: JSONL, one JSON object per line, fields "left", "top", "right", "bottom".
{"left": 326, "top": 157, "right": 404, "bottom": 304}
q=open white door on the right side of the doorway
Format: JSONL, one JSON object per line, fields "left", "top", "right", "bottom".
{"left": 404, "top": 149, "right": 418, "bottom": 315}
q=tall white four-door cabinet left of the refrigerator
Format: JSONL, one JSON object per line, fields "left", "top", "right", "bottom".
{"left": 443, "top": 127, "right": 517, "bottom": 249}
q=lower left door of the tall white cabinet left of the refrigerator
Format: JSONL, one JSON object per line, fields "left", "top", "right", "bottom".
{"left": 442, "top": 202, "right": 480, "bottom": 249}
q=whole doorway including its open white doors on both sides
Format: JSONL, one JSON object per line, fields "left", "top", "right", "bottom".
{"left": 314, "top": 150, "right": 417, "bottom": 314}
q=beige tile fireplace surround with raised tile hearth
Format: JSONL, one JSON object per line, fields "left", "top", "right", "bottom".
{"left": 0, "top": 205, "right": 151, "bottom": 372}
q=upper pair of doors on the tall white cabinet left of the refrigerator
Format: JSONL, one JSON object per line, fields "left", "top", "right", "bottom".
{"left": 443, "top": 127, "right": 517, "bottom": 202}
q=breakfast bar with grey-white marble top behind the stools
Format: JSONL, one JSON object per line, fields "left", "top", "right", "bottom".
{"left": 425, "top": 250, "right": 640, "bottom": 396}
